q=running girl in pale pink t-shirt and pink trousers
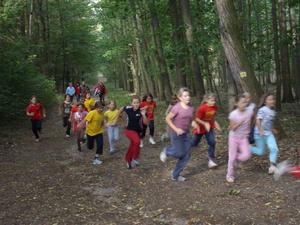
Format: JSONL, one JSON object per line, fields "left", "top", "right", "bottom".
{"left": 226, "top": 95, "right": 253, "bottom": 183}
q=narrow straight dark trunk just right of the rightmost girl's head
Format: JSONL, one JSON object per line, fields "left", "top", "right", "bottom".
{"left": 279, "top": 0, "right": 294, "bottom": 102}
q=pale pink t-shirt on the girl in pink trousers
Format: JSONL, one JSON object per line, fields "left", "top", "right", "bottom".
{"left": 228, "top": 109, "right": 253, "bottom": 138}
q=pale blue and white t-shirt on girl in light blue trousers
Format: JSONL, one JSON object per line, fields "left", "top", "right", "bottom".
{"left": 255, "top": 106, "right": 276, "bottom": 135}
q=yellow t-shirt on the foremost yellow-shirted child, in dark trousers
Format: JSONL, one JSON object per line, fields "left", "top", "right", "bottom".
{"left": 85, "top": 109, "right": 104, "bottom": 136}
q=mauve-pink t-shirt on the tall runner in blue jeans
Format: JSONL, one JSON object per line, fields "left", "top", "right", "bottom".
{"left": 170, "top": 102, "right": 194, "bottom": 133}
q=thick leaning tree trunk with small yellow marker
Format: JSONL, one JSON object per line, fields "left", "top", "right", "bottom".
{"left": 215, "top": 0, "right": 263, "bottom": 100}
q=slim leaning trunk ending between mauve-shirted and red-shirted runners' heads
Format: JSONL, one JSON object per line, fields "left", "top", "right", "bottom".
{"left": 180, "top": 0, "right": 205, "bottom": 98}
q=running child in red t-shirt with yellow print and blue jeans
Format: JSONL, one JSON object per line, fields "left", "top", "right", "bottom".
{"left": 192, "top": 93, "right": 221, "bottom": 168}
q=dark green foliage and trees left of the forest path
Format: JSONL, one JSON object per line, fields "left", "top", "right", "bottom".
{"left": 0, "top": 0, "right": 100, "bottom": 121}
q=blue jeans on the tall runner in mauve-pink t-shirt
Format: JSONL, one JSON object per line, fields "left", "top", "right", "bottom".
{"left": 166, "top": 132, "right": 191, "bottom": 179}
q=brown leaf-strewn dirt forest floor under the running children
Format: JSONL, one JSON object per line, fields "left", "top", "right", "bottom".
{"left": 0, "top": 90, "right": 300, "bottom": 225}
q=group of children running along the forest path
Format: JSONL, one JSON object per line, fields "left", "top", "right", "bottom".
{"left": 27, "top": 88, "right": 278, "bottom": 183}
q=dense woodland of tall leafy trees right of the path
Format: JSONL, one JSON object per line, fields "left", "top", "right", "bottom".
{"left": 100, "top": 0, "right": 300, "bottom": 106}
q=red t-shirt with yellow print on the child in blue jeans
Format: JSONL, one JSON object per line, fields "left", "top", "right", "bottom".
{"left": 193, "top": 102, "right": 218, "bottom": 134}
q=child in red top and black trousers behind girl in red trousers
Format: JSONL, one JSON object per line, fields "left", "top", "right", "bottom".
{"left": 140, "top": 93, "right": 156, "bottom": 148}
